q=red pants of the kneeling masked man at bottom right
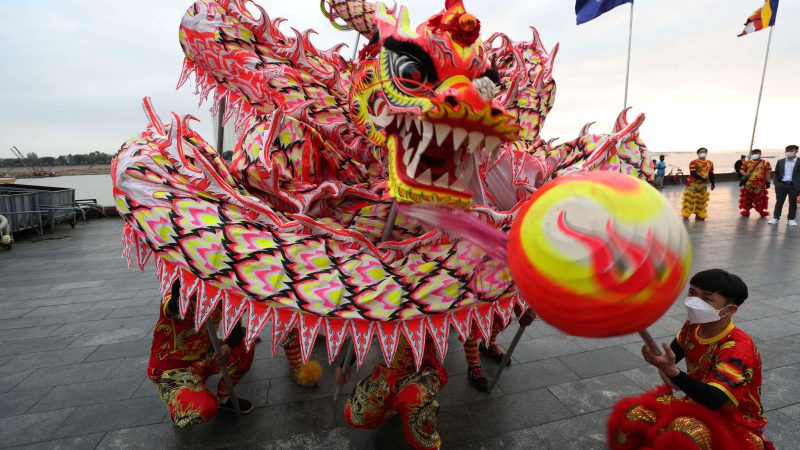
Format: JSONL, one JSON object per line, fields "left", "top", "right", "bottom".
{"left": 607, "top": 387, "right": 774, "bottom": 450}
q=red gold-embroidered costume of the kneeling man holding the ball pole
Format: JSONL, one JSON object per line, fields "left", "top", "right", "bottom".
{"left": 608, "top": 322, "right": 774, "bottom": 450}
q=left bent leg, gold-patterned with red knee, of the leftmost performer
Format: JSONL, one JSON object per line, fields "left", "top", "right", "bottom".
{"left": 152, "top": 367, "right": 219, "bottom": 427}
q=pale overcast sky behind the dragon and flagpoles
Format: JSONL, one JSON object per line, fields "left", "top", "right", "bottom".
{"left": 0, "top": 0, "right": 800, "bottom": 157}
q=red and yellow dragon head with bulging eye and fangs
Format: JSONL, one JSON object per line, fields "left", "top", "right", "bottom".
{"left": 350, "top": 0, "right": 520, "bottom": 206}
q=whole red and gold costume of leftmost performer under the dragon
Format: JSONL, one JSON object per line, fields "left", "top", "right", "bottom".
{"left": 147, "top": 288, "right": 253, "bottom": 427}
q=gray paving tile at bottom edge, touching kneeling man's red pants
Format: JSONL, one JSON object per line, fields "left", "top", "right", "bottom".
{"left": 533, "top": 410, "right": 609, "bottom": 450}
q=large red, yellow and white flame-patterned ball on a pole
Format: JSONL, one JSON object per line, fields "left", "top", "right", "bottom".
{"left": 508, "top": 172, "right": 691, "bottom": 337}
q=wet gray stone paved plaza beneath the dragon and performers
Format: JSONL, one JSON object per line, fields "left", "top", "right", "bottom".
{"left": 0, "top": 183, "right": 800, "bottom": 450}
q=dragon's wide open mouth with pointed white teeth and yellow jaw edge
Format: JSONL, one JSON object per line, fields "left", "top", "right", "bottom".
{"left": 384, "top": 114, "right": 501, "bottom": 203}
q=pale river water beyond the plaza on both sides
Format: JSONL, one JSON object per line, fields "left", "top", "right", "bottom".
{"left": 17, "top": 152, "right": 783, "bottom": 206}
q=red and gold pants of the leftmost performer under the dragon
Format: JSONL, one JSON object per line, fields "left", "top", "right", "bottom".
{"left": 150, "top": 344, "right": 253, "bottom": 427}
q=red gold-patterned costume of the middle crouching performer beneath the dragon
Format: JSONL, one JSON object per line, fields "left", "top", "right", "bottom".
{"left": 344, "top": 337, "right": 447, "bottom": 450}
